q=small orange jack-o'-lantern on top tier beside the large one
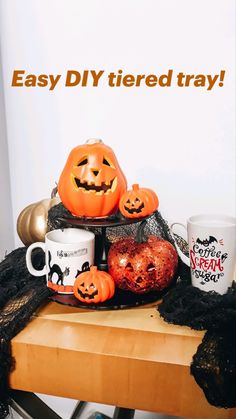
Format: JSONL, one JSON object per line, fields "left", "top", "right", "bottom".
{"left": 119, "top": 184, "right": 159, "bottom": 218}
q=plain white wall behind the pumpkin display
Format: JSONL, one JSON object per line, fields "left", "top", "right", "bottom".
{"left": 0, "top": 0, "right": 235, "bottom": 248}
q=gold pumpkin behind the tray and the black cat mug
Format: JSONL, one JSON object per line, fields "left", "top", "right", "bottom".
{"left": 17, "top": 187, "right": 61, "bottom": 246}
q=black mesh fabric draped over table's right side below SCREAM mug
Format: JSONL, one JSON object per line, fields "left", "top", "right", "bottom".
{"left": 157, "top": 281, "right": 236, "bottom": 408}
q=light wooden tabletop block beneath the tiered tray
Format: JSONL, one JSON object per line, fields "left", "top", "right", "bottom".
{"left": 10, "top": 302, "right": 236, "bottom": 419}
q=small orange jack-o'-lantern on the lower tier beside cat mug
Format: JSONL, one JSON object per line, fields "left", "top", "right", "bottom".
{"left": 73, "top": 266, "right": 115, "bottom": 304}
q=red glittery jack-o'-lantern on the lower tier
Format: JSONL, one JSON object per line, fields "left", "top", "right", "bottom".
{"left": 108, "top": 221, "right": 178, "bottom": 294}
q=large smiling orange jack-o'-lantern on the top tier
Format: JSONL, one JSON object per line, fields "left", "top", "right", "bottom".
{"left": 58, "top": 140, "right": 127, "bottom": 217}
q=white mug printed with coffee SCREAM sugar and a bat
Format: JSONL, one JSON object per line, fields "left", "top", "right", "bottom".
{"left": 171, "top": 214, "right": 236, "bottom": 294}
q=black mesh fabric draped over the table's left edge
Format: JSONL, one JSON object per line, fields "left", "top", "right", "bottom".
{"left": 0, "top": 247, "right": 51, "bottom": 418}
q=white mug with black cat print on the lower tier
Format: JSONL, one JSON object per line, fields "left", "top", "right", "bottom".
{"left": 26, "top": 228, "right": 95, "bottom": 294}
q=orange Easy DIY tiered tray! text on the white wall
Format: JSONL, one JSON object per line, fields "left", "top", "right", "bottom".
{"left": 11, "top": 69, "right": 225, "bottom": 90}
